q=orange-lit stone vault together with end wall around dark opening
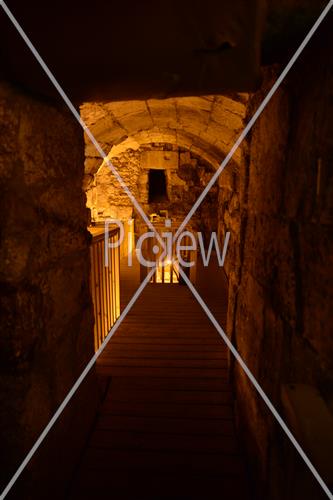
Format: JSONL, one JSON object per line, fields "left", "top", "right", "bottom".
{"left": 80, "top": 93, "right": 248, "bottom": 240}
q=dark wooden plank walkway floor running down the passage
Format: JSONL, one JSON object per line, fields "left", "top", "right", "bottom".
{"left": 70, "top": 262, "right": 248, "bottom": 500}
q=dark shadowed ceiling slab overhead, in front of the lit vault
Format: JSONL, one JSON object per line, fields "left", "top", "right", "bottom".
{"left": 0, "top": 0, "right": 265, "bottom": 102}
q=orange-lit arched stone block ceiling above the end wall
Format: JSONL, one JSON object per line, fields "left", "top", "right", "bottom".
{"left": 80, "top": 94, "right": 248, "bottom": 180}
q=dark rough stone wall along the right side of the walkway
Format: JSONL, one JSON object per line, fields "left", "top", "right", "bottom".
{"left": 219, "top": 18, "right": 333, "bottom": 499}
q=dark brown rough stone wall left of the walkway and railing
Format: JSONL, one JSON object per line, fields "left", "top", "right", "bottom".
{"left": 0, "top": 84, "right": 93, "bottom": 498}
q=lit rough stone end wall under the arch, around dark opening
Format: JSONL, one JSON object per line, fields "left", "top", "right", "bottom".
{"left": 87, "top": 144, "right": 218, "bottom": 240}
